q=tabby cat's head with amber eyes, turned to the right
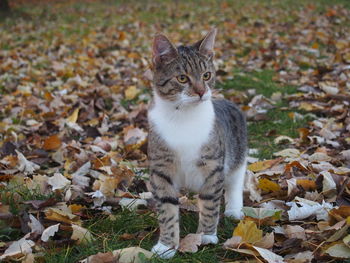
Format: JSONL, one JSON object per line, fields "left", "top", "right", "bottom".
{"left": 152, "top": 29, "right": 216, "bottom": 106}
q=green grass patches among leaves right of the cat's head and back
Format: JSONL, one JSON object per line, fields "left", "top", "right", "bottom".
{"left": 221, "top": 70, "right": 310, "bottom": 159}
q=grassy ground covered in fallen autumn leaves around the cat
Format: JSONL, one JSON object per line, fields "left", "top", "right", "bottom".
{"left": 0, "top": 0, "right": 350, "bottom": 263}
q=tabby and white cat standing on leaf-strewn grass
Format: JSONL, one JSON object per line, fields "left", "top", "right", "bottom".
{"left": 148, "top": 29, "right": 247, "bottom": 258}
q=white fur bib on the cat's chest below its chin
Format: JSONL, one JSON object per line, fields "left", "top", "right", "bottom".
{"left": 148, "top": 95, "right": 215, "bottom": 191}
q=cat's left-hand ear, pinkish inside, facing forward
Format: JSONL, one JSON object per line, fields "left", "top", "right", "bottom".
{"left": 152, "top": 34, "right": 177, "bottom": 65}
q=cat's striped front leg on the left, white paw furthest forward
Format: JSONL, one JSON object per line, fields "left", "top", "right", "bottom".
{"left": 151, "top": 169, "right": 179, "bottom": 258}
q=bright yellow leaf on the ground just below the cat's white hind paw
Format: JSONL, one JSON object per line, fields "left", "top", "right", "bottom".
{"left": 233, "top": 221, "right": 263, "bottom": 244}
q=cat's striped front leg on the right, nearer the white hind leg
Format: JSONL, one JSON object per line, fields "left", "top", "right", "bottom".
{"left": 197, "top": 162, "right": 224, "bottom": 245}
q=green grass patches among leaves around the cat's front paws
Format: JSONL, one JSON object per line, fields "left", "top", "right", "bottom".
{"left": 45, "top": 210, "right": 238, "bottom": 263}
